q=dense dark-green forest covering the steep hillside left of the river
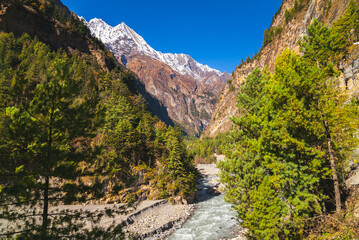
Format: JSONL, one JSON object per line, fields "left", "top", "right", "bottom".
{"left": 0, "top": 1, "right": 196, "bottom": 239}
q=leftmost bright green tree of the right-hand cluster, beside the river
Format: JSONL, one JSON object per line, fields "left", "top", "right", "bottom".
{"left": 218, "top": 69, "right": 276, "bottom": 236}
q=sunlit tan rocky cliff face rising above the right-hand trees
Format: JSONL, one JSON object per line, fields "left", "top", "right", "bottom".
{"left": 204, "top": 0, "right": 359, "bottom": 137}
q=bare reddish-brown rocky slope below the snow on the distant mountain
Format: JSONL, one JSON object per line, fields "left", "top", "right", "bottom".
{"left": 127, "top": 55, "right": 216, "bottom": 135}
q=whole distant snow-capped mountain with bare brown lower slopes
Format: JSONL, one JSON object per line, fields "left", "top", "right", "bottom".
{"left": 85, "top": 18, "right": 230, "bottom": 134}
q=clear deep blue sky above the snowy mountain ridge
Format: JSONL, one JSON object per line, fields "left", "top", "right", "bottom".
{"left": 62, "top": 0, "right": 282, "bottom": 73}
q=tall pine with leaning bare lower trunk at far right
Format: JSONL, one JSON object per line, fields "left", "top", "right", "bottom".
{"left": 301, "top": 19, "right": 359, "bottom": 212}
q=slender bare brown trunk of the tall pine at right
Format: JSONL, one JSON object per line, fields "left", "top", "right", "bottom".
{"left": 324, "top": 121, "right": 342, "bottom": 213}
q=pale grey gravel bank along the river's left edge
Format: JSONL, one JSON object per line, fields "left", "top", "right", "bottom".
{"left": 50, "top": 200, "right": 194, "bottom": 239}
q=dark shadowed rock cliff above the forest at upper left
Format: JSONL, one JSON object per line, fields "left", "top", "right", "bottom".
{"left": 0, "top": 3, "right": 124, "bottom": 70}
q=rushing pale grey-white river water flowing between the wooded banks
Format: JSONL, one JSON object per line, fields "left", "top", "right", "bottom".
{"left": 167, "top": 165, "right": 238, "bottom": 240}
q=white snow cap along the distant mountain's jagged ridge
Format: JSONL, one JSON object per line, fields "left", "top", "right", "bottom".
{"left": 81, "top": 18, "right": 229, "bottom": 81}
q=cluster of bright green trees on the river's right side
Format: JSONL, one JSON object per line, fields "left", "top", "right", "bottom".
{"left": 219, "top": 1, "right": 359, "bottom": 239}
